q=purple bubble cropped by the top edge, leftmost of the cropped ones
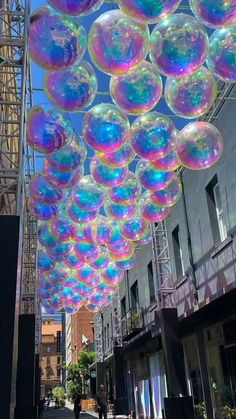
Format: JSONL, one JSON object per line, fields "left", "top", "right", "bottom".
{"left": 48, "top": 0, "right": 104, "bottom": 16}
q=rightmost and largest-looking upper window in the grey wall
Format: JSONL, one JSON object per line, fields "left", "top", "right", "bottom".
{"left": 206, "top": 175, "right": 227, "bottom": 244}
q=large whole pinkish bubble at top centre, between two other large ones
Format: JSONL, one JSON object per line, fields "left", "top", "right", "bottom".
{"left": 88, "top": 10, "right": 150, "bottom": 74}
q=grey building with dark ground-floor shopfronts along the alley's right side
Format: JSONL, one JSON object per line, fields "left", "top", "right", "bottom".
{"left": 95, "top": 85, "right": 236, "bottom": 419}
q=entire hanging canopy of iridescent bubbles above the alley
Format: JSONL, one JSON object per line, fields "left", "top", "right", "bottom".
{"left": 26, "top": 0, "right": 236, "bottom": 314}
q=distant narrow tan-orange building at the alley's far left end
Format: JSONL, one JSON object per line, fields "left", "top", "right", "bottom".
{"left": 40, "top": 318, "right": 62, "bottom": 397}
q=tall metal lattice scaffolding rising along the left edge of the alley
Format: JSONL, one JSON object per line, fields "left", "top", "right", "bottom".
{"left": 0, "top": 0, "right": 40, "bottom": 342}
